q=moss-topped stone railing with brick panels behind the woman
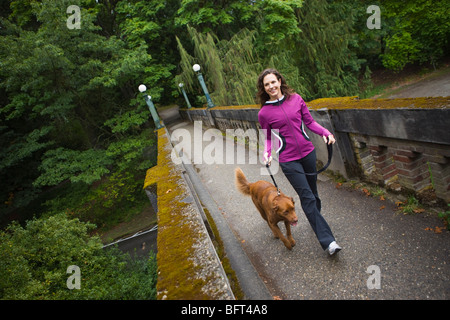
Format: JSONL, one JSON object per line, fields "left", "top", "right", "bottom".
{"left": 180, "top": 97, "right": 450, "bottom": 202}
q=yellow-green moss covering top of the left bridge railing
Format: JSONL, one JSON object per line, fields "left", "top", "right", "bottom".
{"left": 144, "top": 128, "right": 227, "bottom": 300}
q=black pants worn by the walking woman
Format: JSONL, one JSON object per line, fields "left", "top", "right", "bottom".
{"left": 280, "top": 150, "right": 335, "bottom": 250}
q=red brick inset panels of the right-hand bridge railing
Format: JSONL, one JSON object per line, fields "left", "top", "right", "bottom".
{"left": 351, "top": 134, "right": 450, "bottom": 202}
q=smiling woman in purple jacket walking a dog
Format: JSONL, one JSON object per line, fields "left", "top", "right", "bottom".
{"left": 257, "top": 69, "right": 341, "bottom": 255}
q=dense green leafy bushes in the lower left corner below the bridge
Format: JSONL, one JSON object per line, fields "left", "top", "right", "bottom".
{"left": 0, "top": 214, "right": 157, "bottom": 300}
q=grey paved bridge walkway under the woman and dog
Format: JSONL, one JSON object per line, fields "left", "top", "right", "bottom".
{"left": 168, "top": 122, "right": 450, "bottom": 300}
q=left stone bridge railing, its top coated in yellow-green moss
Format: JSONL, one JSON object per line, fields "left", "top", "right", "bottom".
{"left": 144, "top": 128, "right": 235, "bottom": 300}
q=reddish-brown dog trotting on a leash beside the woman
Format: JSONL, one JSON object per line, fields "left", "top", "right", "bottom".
{"left": 235, "top": 168, "right": 298, "bottom": 250}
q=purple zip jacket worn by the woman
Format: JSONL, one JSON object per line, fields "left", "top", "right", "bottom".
{"left": 258, "top": 93, "right": 331, "bottom": 162}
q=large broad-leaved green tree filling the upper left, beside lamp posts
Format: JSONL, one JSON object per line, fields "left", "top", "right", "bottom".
{"left": 0, "top": 0, "right": 157, "bottom": 218}
